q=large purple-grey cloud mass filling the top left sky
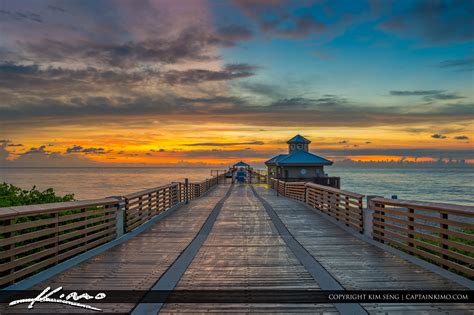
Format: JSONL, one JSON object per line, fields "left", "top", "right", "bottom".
{"left": 0, "top": 0, "right": 252, "bottom": 70}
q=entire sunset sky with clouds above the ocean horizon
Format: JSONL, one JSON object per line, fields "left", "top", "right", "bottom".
{"left": 0, "top": 0, "right": 474, "bottom": 167}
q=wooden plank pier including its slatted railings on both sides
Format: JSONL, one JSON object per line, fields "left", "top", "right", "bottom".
{"left": 0, "top": 174, "right": 474, "bottom": 314}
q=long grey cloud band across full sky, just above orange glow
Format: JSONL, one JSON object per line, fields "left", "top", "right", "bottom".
{"left": 0, "top": 93, "right": 474, "bottom": 127}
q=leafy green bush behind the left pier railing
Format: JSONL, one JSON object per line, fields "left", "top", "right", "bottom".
{"left": 0, "top": 183, "right": 74, "bottom": 207}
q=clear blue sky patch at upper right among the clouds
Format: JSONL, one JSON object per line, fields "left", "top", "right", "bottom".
{"left": 214, "top": 1, "right": 474, "bottom": 105}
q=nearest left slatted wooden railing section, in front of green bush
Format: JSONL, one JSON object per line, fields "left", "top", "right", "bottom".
{"left": 0, "top": 198, "right": 119, "bottom": 287}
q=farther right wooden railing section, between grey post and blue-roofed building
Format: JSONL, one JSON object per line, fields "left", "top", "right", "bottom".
{"left": 270, "top": 178, "right": 364, "bottom": 233}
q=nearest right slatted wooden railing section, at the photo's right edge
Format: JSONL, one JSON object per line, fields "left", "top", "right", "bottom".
{"left": 369, "top": 198, "right": 474, "bottom": 278}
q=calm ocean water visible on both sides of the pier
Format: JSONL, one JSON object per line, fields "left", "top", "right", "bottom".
{"left": 0, "top": 165, "right": 474, "bottom": 205}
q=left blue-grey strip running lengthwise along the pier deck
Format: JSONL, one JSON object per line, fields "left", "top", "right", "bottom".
{"left": 131, "top": 186, "right": 233, "bottom": 315}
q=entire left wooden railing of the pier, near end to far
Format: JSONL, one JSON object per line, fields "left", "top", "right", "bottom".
{"left": 0, "top": 174, "right": 225, "bottom": 287}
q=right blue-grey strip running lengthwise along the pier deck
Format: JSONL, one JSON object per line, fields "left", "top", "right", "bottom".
{"left": 250, "top": 186, "right": 368, "bottom": 315}
